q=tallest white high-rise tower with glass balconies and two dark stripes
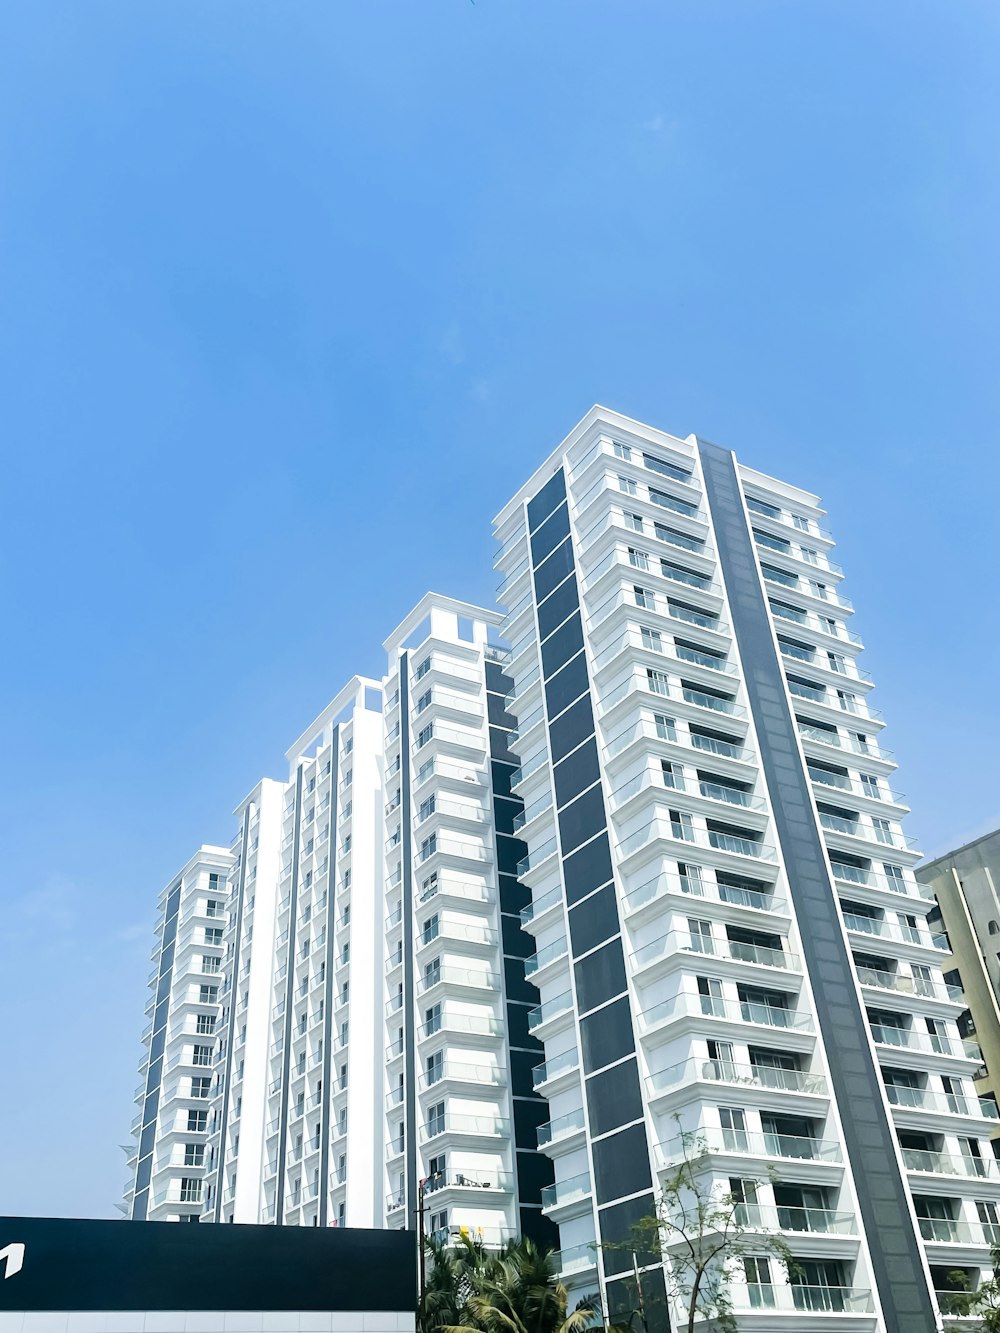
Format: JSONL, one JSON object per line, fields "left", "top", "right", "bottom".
{"left": 496, "top": 408, "right": 1000, "bottom": 1333}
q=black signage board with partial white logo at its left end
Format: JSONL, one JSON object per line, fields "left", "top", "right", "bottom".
{"left": 0, "top": 1217, "right": 416, "bottom": 1313}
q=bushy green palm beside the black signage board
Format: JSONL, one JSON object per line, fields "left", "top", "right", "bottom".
{"left": 423, "top": 1237, "right": 599, "bottom": 1333}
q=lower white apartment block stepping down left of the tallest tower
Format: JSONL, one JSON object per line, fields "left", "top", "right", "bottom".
{"left": 127, "top": 595, "right": 556, "bottom": 1244}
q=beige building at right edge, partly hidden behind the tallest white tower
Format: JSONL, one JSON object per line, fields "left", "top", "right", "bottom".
{"left": 916, "top": 829, "right": 1000, "bottom": 1137}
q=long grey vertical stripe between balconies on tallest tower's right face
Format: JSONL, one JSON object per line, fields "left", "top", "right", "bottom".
{"left": 699, "top": 440, "right": 937, "bottom": 1333}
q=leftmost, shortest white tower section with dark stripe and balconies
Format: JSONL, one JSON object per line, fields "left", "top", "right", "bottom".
{"left": 123, "top": 846, "right": 232, "bottom": 1222}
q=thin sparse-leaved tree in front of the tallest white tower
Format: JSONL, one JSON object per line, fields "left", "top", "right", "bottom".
{"left": 605, "top": 1130, "right": 792, "bottom": 1333}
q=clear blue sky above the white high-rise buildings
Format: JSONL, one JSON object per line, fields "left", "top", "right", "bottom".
{"left": 0, "top": 0, "right": 1000, "bottom": 1216}
